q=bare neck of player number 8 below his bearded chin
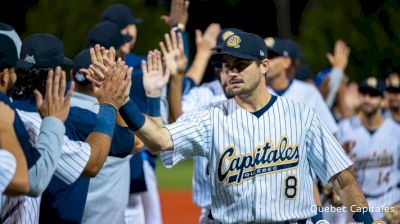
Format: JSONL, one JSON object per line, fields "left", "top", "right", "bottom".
{"left": 235, "top": 82, "right": 271, "bottom": 112}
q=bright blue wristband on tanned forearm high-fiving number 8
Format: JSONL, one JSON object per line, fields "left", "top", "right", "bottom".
{"left": 93, "top": 104, "right": 117, "bottom": 138}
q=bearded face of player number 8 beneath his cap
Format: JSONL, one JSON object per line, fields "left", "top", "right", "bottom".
{"left": 221, "top": 55, "right": 268, "bottom": 96}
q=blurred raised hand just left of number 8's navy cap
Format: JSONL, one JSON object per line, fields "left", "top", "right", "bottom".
{"left": 196, "top": 23, "right": 221, "bottom": 54}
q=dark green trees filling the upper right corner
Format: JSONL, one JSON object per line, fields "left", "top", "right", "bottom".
{"left": 297, "top": 0, "right": 400, "bottom": 81}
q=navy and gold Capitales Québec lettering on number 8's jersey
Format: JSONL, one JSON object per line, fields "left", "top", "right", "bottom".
{"left": 218, "top": 136, "right": 299, "bottom": 185}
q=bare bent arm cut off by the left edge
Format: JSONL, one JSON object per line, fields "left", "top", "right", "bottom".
{"left": 0, "top": 127, "right": 29, "bottom": 195}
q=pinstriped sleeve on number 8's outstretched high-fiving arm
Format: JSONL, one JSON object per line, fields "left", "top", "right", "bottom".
{"left": 161, "top": 110, "right": 212, "bottom": 168}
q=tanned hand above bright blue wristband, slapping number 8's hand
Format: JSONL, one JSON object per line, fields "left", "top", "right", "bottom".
{"left": 93, "top": 61, "right": 133, "bottom": 110}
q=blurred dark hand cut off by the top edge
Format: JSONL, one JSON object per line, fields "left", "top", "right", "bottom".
{"left": 161, "top": 0, "right": 189, "bottom": 28}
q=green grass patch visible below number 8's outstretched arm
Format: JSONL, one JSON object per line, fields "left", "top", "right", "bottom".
{"left": 156, "top": 159, "right": 193, "bottom": 190}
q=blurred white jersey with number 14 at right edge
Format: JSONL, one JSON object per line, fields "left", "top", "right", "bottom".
{"left": 338, "top": 116, "right": 400, "bottom": 219}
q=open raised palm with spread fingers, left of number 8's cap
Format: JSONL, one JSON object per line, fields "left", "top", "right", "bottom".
{"left": 159, "top": 30, "right": 188, "bottom": 75}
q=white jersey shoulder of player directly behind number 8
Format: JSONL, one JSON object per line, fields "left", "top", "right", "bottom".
{"left": 268, "top": 79, "right": 338, "bottom": 134}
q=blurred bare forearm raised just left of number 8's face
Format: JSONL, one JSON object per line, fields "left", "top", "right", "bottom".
{"left": 186, "top": 50, "right": 211, "bottom": 85}
